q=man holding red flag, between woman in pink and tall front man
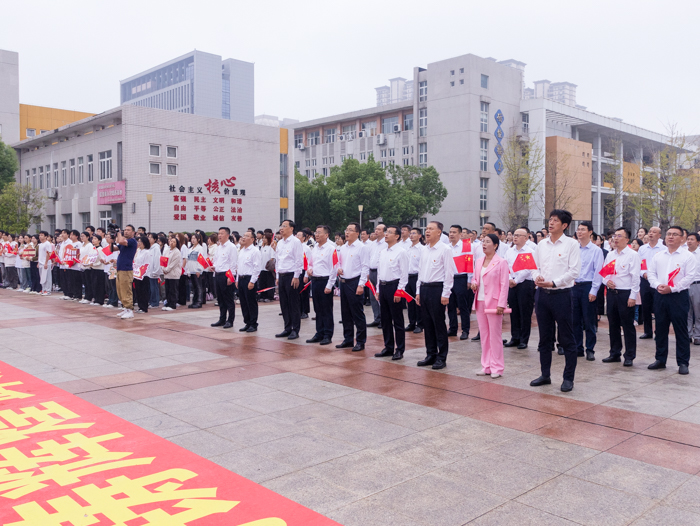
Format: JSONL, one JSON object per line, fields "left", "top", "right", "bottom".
{"left": 503, "top": 228, "right": 535, "bottom": 349}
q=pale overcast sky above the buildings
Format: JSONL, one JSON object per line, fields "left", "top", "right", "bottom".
{"left": 0, "top": 0, "right": 700, "bottom": 134}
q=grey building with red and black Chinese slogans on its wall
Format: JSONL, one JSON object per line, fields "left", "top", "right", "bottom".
{"left": 13, "top": 104, "right": 294, "bottom": 232}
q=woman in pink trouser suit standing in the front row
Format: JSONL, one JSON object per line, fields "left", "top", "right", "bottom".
{"left": 472, "top": 234, "right": 509, "bottom": 378}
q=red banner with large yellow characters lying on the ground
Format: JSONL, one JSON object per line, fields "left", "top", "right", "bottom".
{"left": 0, "top": 362, "right": 340, "bottom": 526}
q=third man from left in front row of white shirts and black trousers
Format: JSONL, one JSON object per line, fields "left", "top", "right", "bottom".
{"left": 275, "top": 219, "right": 304, "bottom": 340}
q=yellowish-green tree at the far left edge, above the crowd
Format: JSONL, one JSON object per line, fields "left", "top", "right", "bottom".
{"left": 0, "top": 183, "right": 44, "bottom": 234}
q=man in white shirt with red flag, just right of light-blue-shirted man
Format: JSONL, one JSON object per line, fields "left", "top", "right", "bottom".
{"left": 603, "top": 228, "right": 641, "bottom": 367}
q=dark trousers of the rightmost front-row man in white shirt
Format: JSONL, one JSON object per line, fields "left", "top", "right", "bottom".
{"left": 642, "top": 289, "right": 690, "bottom": 366}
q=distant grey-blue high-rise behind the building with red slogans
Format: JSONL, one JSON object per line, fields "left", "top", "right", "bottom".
{"left": 120, "top": 50, "right": 255, "bottom": 123}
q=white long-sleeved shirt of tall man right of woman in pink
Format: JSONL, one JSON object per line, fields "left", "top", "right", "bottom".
{"left": 532, "top": 235, "right": 581, "bottom": 289}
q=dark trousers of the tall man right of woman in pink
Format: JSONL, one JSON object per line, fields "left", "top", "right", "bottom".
{"left": 535, "top": 289, "right": 576, "bottom": 382}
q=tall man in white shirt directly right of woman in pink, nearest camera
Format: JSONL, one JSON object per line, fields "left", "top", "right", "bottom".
{"left": 530, "top": 210, "right": 581, "bottom": 393}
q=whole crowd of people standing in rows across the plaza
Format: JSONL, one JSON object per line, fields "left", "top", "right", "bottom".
{"left": 0, "top": 210, "right": 700, "bottom": 392}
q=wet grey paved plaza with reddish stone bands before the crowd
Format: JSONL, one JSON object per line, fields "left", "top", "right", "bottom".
{"left": 0, "top": 290, "right": 700, "bottom": 526}
